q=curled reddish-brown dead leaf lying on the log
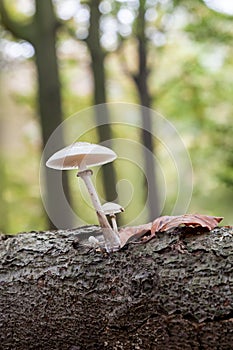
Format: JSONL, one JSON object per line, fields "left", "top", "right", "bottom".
{"left": 119, "top": 214, "right": 223, "bottom": 247}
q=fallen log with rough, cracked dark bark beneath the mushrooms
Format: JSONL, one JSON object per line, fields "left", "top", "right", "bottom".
{"left": 0, "top": 226, "right": 233, "bottom": 350}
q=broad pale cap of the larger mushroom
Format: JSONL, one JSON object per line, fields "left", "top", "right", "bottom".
{"left": 46, "top": 142, "right": 117, "bottom": 170}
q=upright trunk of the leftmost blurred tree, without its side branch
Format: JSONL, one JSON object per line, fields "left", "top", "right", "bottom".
{"left": 33, "top": 0, "right": 72, "bottom": 228}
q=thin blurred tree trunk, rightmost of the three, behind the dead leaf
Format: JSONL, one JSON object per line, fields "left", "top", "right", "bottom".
{"left": 133, "top": 0, "right": 160, "bottom": 220}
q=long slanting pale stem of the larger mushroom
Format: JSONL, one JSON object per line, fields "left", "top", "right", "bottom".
{"left": 77, "top": 169, "right": 120, "bottom": 252}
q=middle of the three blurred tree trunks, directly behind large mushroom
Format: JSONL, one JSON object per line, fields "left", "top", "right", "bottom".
{"left": 86, "top": 0, "right": 117, "bottom": 201}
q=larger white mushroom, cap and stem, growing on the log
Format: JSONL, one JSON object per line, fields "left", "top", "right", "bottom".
{"left": 46, "top": 142, "right": 120, "bottom": 252}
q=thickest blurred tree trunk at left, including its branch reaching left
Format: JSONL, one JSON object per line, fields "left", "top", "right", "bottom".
{"left": 0, "top": 0, "right": 72, "bottom": 228}
